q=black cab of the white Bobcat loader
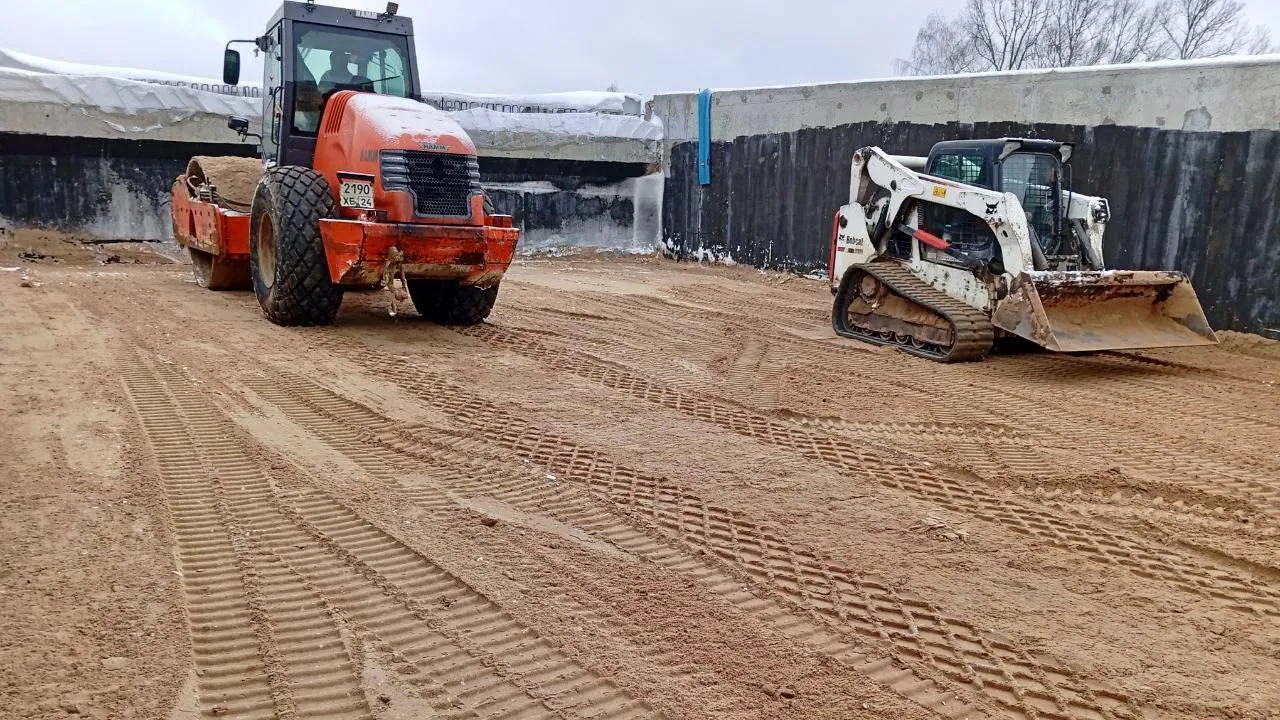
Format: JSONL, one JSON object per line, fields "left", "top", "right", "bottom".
{"left": 925, "top": 138, "right": 1074, "bottom": 255}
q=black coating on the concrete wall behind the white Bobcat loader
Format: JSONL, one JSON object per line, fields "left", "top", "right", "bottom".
{"left": 663, "top": 123, "right": 1280, "bottom": 332}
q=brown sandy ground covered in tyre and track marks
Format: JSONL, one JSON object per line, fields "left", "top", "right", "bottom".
{"left": 0, "top": 245, "right": 1280, "bottom": 720}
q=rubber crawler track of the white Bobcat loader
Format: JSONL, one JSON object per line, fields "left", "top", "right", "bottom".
{"left": 832, "top": 261, "right": 996, "bottom": 363}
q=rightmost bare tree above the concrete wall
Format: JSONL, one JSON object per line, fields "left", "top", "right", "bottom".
{"left": 1158, "top": 0, "right": 1254, "bottom": 60}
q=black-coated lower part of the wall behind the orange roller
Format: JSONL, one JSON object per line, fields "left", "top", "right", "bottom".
{"left": 0, "top": 133, "right": 662, "bottom": 252}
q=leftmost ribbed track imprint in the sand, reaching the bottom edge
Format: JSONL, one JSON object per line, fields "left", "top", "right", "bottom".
{"left": 124, "top": 359, "right": 372, "bottom": 720}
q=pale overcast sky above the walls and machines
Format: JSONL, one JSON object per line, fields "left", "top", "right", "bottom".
{"left": 0, "top": 0, "right": 1280, "bottom": 94}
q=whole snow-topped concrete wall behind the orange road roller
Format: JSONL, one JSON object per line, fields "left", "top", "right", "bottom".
{"left": 0, "top": 61, "right": 662, "bottom": 250}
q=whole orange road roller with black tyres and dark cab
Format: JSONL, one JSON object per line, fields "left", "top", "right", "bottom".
{"left": 173, "top": 1, "right": 520, "bottom": 325}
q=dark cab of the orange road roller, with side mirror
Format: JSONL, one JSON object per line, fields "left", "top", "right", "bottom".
{"left": 224, "top": 0, "right": 421, "bottom": 168}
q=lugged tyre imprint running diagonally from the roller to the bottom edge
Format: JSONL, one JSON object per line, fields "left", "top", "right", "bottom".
{"left": 290, "top": 337, "right": 1140, "bottom": 720}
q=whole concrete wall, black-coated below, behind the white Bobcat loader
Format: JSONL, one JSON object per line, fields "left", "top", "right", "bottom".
{"left": 653, "top": 56, "right": 1280, "bottom": 332}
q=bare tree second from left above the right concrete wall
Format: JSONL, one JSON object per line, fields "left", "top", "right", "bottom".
{"left": 963, "top": 0, "right": 1048, "bottom": 70}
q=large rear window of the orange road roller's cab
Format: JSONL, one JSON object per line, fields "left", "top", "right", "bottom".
{"left": 293, "top": 23, "right": 413, "bottom": 135}
